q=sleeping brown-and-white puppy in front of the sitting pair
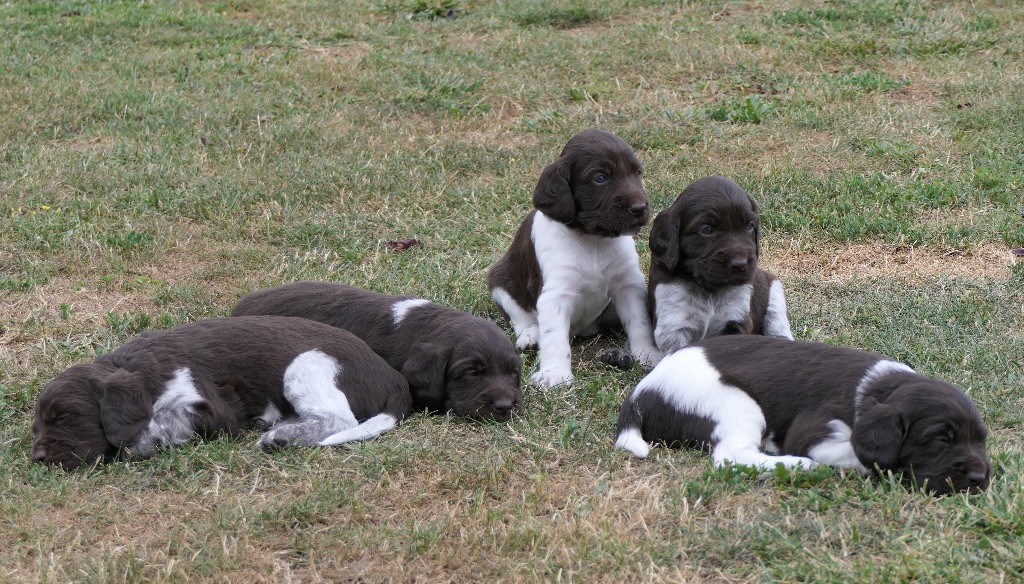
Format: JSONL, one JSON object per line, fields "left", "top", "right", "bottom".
{"left": 615, "top": 335, "right": 992, "bottom": 495}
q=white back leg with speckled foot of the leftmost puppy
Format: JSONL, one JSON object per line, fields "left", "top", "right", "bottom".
{"left": 259, "top": 350, "right": 358, "bottom": 450}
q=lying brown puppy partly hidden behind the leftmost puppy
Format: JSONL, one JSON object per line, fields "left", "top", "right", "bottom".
{"left": 233, "top": 282, "right": 523, "bottom": 420}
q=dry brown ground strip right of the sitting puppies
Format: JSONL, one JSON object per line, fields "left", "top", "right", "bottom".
{"left": 764, "top": 237, "right": 1016, "bottom": 282}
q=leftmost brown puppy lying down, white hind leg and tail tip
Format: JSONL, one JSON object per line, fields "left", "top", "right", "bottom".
{"left": 32, "top": 317, "right": 413, "bottom": 469}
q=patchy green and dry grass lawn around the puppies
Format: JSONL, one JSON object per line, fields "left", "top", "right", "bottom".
{"left": 0, "top": 0, "right": 1024, "bottom": 582}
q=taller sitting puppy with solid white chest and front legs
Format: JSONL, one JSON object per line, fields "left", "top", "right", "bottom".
{"left": 487, "top": 130, "right": 662, "bottom": 387}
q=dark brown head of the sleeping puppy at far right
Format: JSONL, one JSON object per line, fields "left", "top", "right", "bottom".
{"left": 852, "top": 375, "right": 992, "bottom": 495}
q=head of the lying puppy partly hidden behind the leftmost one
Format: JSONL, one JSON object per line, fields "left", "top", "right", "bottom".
{"left": 401, "top": 319, "right": 523, "bottom": 421}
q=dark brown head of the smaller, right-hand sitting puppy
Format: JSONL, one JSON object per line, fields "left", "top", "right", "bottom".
{"left": 650, "top": 176, "right": 761, "bottom": 290}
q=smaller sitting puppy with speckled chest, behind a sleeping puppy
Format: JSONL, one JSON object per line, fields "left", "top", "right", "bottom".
{"left": 647, "top": 176, "right": 793, "bottom": 354}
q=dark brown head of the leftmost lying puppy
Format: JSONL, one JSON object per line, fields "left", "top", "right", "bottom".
{"left": 32, "top": 365, "right": 152, "bottom": 470}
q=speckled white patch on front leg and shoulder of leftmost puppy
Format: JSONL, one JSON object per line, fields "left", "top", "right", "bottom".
{"left": 128, "top": 367, "right": 203, "bottom": 458}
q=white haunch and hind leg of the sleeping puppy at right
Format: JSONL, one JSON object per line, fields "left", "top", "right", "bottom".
{"left": 633, "top": 347, "right": 815, "bottom": 470}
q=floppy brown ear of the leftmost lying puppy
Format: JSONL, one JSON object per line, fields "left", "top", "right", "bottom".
{"left": 99, "top": 369, "right": 153, "bottom": 448}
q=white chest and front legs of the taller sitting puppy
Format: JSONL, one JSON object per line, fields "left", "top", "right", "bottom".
{"left": 524, "top": 212, "right": 662, "bottom": 387}
